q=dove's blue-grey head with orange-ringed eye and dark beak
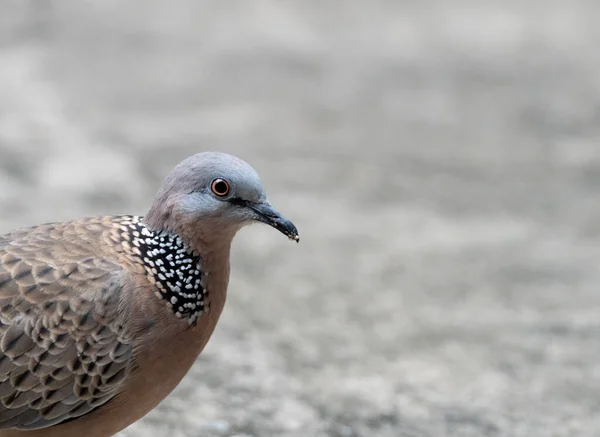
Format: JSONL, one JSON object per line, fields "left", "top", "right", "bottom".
{"left": 145, "top": 152, "right": 299, "bottom": 244}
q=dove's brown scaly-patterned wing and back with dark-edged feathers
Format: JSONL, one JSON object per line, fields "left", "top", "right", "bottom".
{"left": 0, "top": 218, "right": 132, "bottom": 430}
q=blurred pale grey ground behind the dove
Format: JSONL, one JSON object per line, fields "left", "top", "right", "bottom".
{"left": 0, "top": 0, "right": 600, "bottom": 437}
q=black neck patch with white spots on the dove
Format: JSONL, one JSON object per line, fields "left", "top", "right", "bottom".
{"left": 120, "top": 216, "right": 209, "bottom": 325}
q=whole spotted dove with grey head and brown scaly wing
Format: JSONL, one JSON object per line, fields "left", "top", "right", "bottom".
{"left": 0, "top": 152, "right": 299, "bottom": 437}
